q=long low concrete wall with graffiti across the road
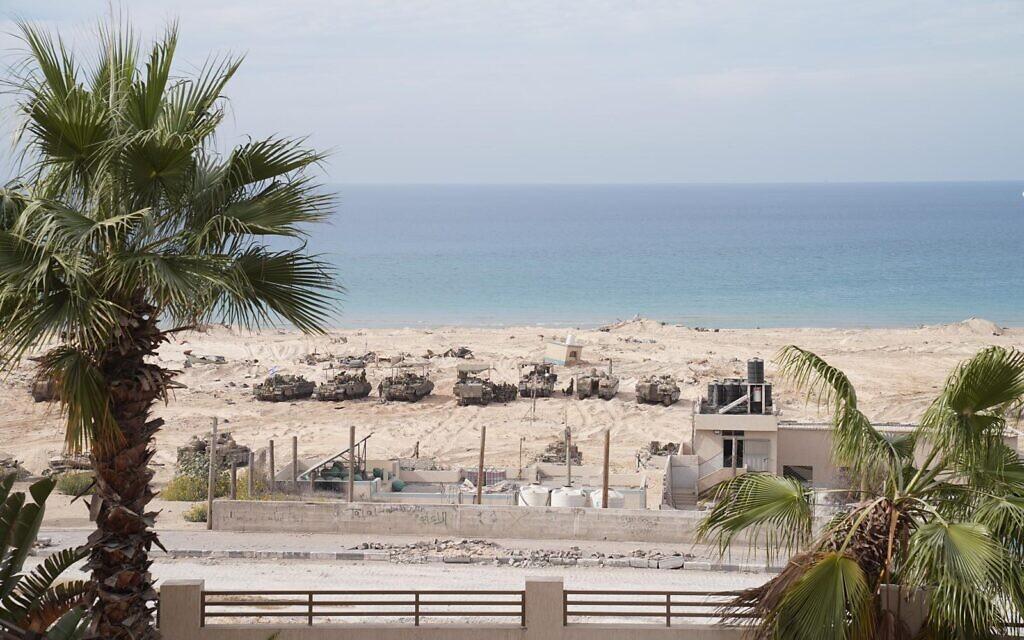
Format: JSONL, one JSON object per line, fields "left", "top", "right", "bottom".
{"left": 213, "top": 500, "right": 702, "bottom": 543}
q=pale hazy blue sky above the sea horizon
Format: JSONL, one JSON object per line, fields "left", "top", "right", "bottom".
{"left": 0, "top": 0, "right": 1024, "bottom": 182}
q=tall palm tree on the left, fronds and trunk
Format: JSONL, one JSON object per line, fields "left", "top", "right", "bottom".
{"left": 0, "top": 25, "right": 337, "bottom": 640}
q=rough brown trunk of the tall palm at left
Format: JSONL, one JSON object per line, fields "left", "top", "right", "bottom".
{"left": 86, "top": 297, "right": 174, "bottom": 640}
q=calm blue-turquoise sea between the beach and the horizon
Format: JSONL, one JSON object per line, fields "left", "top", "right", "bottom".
{"left": 310, "top": 181, "right": 1024, "bottom": 328}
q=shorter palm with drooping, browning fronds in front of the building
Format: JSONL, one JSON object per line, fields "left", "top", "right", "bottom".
{"left": 699, "top": 346, "right": 1024, "bottom": 640}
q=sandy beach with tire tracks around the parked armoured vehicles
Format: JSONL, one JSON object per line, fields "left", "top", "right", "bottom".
{"left": 0, "top": 319, "right": 1024, "bottom": 480}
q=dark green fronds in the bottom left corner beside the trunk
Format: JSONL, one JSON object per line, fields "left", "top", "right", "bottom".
{"left": 0, "top": 474, "right": 89, "bottom": 640}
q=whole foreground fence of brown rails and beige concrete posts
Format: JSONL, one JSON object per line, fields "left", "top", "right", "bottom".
{"left": 160, "top": 578, "right": 743, "bottom": 640}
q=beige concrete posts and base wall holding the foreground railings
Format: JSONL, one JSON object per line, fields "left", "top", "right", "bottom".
{"left": 160, "top": 578, "right": 742, "bottom": 640}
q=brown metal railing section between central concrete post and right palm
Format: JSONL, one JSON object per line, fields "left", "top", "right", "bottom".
{"left": 562, "top": 589, "right": 757, "bottom": 627}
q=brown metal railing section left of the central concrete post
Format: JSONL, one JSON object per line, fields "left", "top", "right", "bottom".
{"left": 202, "top": 590, "right": 526, "bottom": 627}
